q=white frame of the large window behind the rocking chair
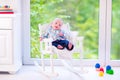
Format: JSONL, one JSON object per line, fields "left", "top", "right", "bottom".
{"left": 22, "top": 0, "right": 106, "bottom": 66}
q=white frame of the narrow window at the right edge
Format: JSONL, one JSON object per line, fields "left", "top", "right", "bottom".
{"left": 106, "top": 0, "right": 120, "bottom": 66}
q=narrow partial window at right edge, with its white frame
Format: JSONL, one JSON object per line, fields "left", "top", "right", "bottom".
{"left": 106, "top": 0, "right": 120, "bottom": 66}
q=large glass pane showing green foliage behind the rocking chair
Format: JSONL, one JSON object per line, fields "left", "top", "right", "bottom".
{"left": 30, "top": 0, "right": 99, "bottom": 59}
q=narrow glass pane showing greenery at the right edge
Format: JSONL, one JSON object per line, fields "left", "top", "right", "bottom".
{"left": 111, "top": 0, "right": 120, "bottom": 60}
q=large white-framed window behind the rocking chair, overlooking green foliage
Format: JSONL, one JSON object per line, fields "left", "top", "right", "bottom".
{"left": 23, "top": 0, "right": 119, "bottom": 65}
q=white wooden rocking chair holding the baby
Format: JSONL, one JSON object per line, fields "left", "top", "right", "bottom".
{"left": 38, "top": 23, "right": 83, "bottom": 76}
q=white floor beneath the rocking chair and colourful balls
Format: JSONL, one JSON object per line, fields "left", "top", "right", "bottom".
{"left": 0, "top": 66, "right": 120, "bottom": 80}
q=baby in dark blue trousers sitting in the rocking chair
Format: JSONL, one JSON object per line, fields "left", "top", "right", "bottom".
{"left": 40, "top": 18, "right": 74, "bottom": 51}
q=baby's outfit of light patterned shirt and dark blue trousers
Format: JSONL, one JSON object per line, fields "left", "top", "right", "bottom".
{"left": 42, "top": 27, "right": 74, "bottom": 50}
